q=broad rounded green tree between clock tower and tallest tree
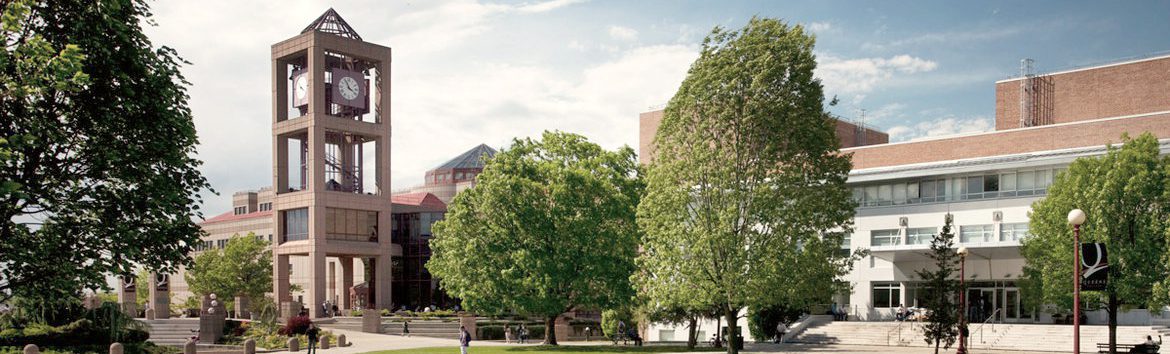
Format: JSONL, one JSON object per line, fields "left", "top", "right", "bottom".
{"left": 426, "top": 132, "right": 642, "bottom": 345}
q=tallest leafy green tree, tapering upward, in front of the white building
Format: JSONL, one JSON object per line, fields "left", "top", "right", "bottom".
{"left": 638, "top": 18, "right": 855, "bottom": 353}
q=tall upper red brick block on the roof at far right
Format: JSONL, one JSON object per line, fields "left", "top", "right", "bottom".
{"left": 996, "top": 57, "right": 1170, "bottom": 131}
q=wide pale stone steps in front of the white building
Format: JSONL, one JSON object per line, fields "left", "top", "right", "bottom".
{"left": 792, "top": 321, "right": 1155, "bottom": 353}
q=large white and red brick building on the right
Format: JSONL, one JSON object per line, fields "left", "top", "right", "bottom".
{"left": 639, "top": 56, "right": 1170, "bottom": 340}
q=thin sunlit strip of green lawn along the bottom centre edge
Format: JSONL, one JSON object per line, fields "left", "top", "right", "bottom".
{"left": 366, "top": 343, "right": 727, "bottom": 354}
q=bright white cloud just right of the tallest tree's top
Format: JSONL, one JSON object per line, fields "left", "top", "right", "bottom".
{"left": 817, "top": 54, "right": 938, "bottom": 96}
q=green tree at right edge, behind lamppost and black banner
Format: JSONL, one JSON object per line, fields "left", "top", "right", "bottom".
{"left": 1020, "top": 133, "right": 1170, "bottom": 352}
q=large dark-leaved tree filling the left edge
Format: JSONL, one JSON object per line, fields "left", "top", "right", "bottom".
{"left": 0, "top": 0, "right": 209, "bottom": 300}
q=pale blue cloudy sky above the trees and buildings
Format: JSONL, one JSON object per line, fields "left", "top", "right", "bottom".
{"left": 146, "top": 0, "right": 1170, "bottom": 217}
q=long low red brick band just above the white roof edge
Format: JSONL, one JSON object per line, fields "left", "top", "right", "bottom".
{"left": 842, "top": 113, "right": 1170, "bottom": 169}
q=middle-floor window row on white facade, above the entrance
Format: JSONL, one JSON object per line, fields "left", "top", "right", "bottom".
{"left": 865, "top": 222, "right": 1028, "bottom": 249}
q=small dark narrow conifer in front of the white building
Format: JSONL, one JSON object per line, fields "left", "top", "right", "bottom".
{"left": 916, "top": 213, "right": 964, "bottom": 354}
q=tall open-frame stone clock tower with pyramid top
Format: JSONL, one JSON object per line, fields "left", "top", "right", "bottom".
{"left": 271, "top": 8, "right": 401, "bottom": 318}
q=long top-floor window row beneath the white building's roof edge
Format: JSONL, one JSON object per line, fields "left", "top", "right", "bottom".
{"left": 853, "top": 168, "right": 1064, "bottom": 207}
